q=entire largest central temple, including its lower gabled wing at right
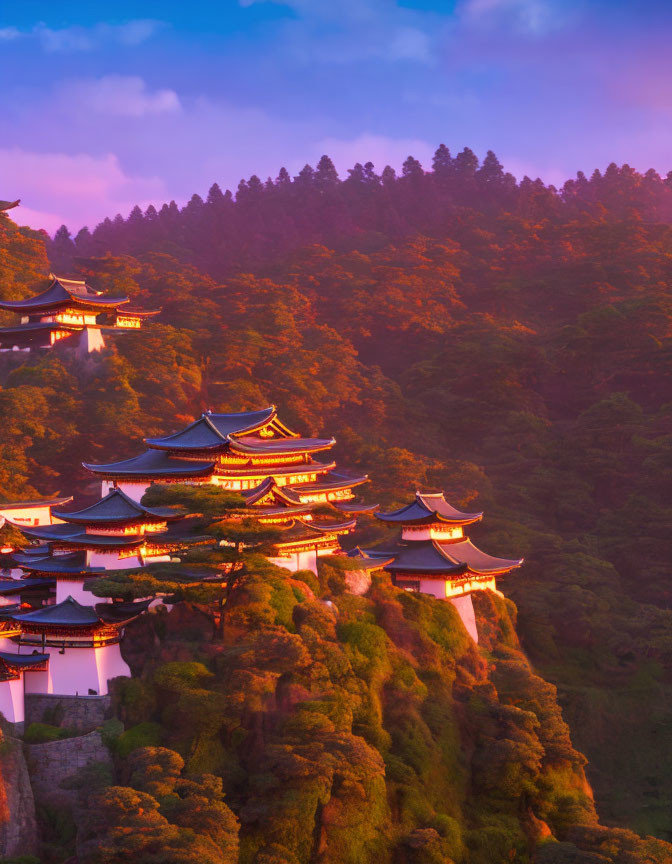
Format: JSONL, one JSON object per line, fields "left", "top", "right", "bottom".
{"left": 84, "top": 405, "right": 372, "bottom": 571}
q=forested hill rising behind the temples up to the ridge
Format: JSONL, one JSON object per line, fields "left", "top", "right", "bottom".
{"left": 0, "top": 148, "right": 672, "bottom": 860}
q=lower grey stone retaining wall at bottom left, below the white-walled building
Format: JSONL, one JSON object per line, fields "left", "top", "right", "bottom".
{"left": 24, "top": 732, "right": 112, "bottom": 804}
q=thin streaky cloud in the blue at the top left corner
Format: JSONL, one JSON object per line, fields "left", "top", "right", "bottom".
{"left": 0, "top": 18, "right": 165, "bottom": 53}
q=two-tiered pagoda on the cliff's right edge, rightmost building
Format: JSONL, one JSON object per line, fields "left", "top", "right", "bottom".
{"left": 364, "top": 492, "right": 523, "bottom": 641}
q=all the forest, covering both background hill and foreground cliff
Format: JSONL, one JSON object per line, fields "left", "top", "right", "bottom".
{"left": 0, "top": 145, "right": 672, "bottom": 864}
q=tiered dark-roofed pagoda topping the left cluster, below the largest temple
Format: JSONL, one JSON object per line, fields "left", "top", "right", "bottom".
{"left": 13, "top": 489, "right": 207, "bottom": 603}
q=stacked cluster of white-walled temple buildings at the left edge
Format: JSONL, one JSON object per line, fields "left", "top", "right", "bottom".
{"left": 0, "top": 489, "right": 207, "bottom": 723}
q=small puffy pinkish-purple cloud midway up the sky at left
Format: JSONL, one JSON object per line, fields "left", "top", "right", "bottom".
{"left": 59, "top": 75, "right": 181, "bottom": 117}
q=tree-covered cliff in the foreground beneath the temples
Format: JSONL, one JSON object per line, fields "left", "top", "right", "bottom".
{"left": 92, "top": 562, "right": 632, "bottom": 864}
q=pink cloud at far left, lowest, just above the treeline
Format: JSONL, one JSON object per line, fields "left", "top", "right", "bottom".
{"left": 0, "top": 147, "right": 168, "bottom": 231}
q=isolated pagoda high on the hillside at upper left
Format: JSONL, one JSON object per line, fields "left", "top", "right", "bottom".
{"left": 0, "top": 273, "right": 159, "bottom": 354}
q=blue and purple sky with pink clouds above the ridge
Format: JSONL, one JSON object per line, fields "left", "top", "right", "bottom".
{"left": 0, "top": 0, "right": 672, "bottom": 233}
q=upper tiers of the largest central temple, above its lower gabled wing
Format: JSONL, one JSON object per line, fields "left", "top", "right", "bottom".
{"left": 84, "top": 405, "right": 368, "bottom": 504}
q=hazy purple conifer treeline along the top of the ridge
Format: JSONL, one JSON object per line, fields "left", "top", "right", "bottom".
{"left": 50, "top": 144, "right": 672, "bottom": 278}
